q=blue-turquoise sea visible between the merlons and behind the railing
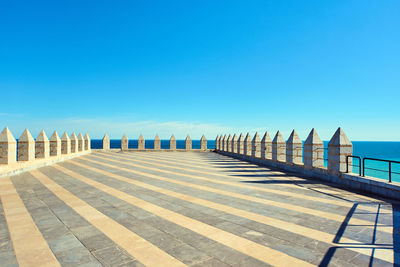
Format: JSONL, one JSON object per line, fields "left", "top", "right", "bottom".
{"left": 91, "top": 139, "right": 400, "bottom": 182}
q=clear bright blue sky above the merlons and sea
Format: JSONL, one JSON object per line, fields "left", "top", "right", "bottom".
{"left": 0, "top": 0, "right": 400, "bottom": 140}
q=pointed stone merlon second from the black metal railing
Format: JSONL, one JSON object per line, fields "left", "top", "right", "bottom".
{"left": 304, "top": 129, "right": 324, "bottom": 169}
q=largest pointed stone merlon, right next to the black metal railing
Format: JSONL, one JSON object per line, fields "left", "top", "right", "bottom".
{"left": 328, "top": 128, "right": 353, "bottom": 175}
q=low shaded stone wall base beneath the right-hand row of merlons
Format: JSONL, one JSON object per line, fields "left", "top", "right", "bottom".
{"left": 215, "top": 151, "right": 400, "bottom": 200}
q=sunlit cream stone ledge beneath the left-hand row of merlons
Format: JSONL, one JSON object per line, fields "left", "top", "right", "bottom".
{"left": 0, "top": 150, "right": 91, "bottom": 178}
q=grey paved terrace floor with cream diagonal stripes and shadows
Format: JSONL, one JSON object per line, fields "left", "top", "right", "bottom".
{"left": 0, "top": 152, "right": 400, "bottom": 267}
